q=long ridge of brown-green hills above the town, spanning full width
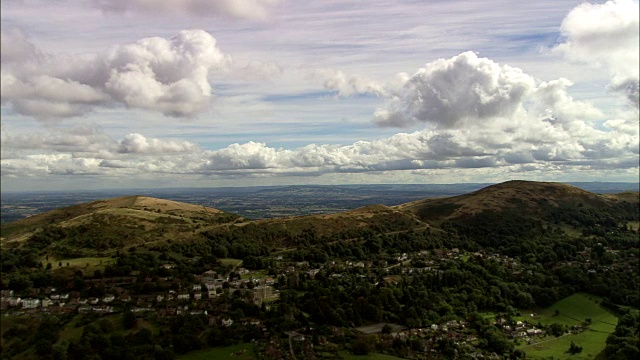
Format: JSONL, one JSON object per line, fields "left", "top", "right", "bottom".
{"left": 1, "top": 181, "right": 639, "bottom": 257}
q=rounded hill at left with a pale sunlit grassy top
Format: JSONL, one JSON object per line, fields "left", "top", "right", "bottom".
{"left": 1, "top": 196, "right": 239, "bottom": 255}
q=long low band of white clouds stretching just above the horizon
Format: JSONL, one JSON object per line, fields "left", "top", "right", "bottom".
{"left": 2, "top": 115, "right": 639, "bottom": 177}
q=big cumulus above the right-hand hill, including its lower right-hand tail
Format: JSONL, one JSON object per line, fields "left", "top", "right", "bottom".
{"left": 374, "top": 52, "right": 603, "bottom": 130}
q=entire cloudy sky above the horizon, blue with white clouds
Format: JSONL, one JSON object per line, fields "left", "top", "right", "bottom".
{"left": 0, "top": 0, "right": 640, "bottom": 191}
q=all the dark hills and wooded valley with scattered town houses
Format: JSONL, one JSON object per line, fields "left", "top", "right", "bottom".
{"left": 1, "top": 181, "right": 640, "bottom": 359}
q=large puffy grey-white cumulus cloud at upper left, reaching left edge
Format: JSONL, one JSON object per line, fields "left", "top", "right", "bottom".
{"left": 2, "top": 30, "right": 231, "bottom": 119}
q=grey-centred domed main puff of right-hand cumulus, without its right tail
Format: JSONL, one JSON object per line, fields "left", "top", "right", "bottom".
{"left": 375, "top": 52, "right": 535, "bottom": 129}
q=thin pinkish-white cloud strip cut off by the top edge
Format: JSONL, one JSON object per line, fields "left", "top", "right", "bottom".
{"left": 92, "top": 0, "right": 281, "bottom": 20}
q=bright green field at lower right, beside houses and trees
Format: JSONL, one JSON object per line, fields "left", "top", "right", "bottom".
{"left": 518, "top": 294, "right": 618, "bottom": 359}
